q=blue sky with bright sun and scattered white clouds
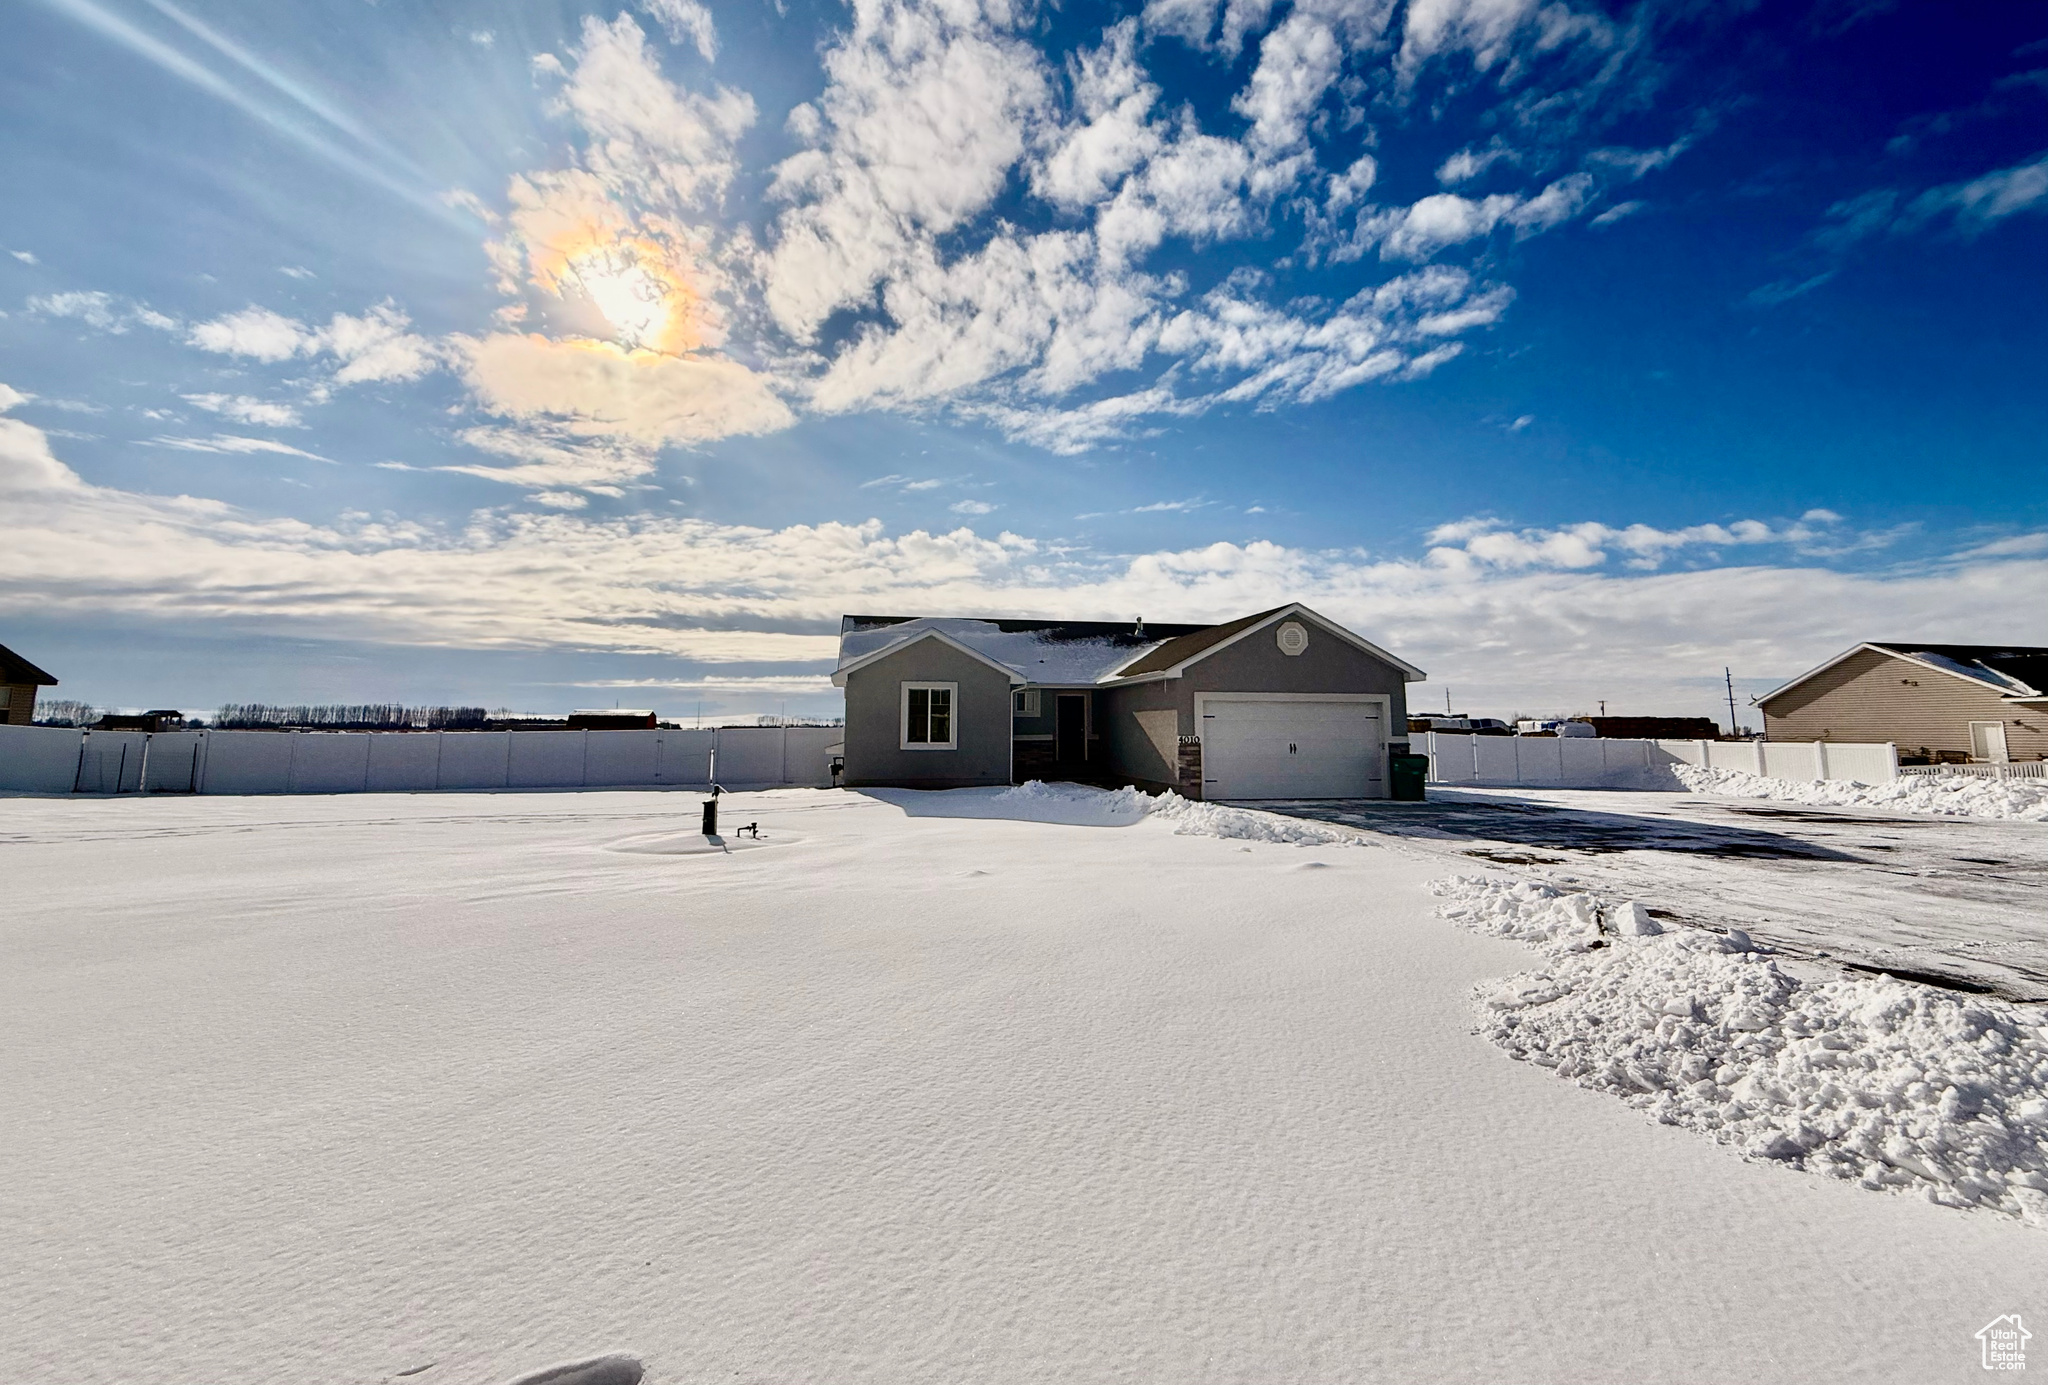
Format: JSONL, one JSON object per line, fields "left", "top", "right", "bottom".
{"left": 0, "top": 0, "right": 2048, "bottom": 715}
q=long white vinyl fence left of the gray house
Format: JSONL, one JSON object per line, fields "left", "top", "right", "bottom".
{"left": 0, "top": 725, "right": 846, "bottom": 793}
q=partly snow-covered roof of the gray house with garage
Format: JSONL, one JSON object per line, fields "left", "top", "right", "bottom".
{"left": 831, "top": 604, "right": 1423, "bottom": 686}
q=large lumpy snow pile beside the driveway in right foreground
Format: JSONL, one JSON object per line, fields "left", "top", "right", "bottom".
{"left": 1430, "top": 875, "right": 2048, "bottom": 1227}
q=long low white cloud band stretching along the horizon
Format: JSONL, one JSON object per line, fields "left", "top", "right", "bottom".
{"left": 0, "top": 395, "right": 2048, "bottom": 711}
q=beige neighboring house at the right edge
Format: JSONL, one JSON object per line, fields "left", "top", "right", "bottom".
{"left": 1757, "top": 643, "right": 2048, "bottom": 764}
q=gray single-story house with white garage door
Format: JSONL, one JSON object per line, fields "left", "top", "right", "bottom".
{"left": 831, "top": 604, "right": 1423, "bottom": 799}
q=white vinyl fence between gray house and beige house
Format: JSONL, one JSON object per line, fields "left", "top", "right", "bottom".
{"left": 1409, "top": 731, "right": 1898, "bottom": 789}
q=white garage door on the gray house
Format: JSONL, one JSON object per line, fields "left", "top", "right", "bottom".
{"left": 1202, "top": 699, "right": 1386, "bottom": 799}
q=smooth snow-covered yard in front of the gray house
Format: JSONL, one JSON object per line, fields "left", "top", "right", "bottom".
{"left": 0, "top": 791, "right": 2048, "bottom": 1385}
